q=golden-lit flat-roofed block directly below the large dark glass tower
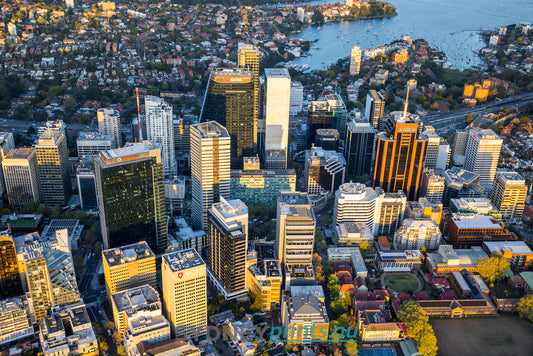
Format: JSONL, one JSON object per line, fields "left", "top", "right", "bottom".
{"left": 102, "top": 241, "right": 157, "bottom": 297}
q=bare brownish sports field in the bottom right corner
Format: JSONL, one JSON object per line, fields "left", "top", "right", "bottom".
{"left": 430, "top": 315, "right": 533, "bottom": 356}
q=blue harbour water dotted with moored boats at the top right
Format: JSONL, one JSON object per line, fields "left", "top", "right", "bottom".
{"left": 286, "top": 0, "right": 533, "bottom": 70}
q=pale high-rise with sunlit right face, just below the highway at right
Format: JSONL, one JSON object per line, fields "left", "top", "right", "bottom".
{"left": 464, "top": 129, "right": 503, "bottom": 184}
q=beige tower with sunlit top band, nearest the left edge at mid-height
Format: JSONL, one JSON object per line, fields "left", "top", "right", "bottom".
{"left": 2, "top": 148, "right": 41, "bottom": 206}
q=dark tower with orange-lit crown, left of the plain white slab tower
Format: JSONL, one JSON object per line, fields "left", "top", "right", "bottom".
{"left": 201, "top": 69, "right": 257, "bottom": 165}
